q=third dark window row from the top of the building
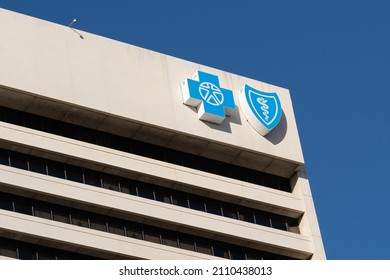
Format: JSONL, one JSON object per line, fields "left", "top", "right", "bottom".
{"left": 0, "top": 193, "right": 296, "bottom": 260}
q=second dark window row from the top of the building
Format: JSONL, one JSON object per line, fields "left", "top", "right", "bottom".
{"left": 0, "top": 149, "right": 299, "bottom": 233}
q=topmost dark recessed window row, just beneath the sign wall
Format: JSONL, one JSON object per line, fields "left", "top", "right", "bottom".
{"left": 0, "top": 106, "right": 291, "bottom": 192}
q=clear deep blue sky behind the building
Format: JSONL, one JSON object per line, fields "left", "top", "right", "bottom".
{"left": 0, "top": 0, "right": 390, "bottom": 259}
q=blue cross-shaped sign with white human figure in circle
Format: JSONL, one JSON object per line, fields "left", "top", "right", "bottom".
{"left": 182, "top": 71, "right": 236, "bottom": 124}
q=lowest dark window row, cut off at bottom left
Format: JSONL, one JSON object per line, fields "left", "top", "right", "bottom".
{"left": 0, "top": 237, "right": 98, "bottom": 260}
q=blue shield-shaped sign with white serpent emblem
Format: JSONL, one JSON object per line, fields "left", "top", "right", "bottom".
{"left": 239, "top": 85, "right": 282, "bottom": 136}
